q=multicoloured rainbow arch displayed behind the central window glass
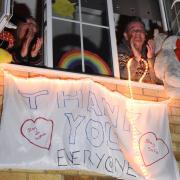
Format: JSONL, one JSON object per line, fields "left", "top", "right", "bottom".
{"left": 57, "top": 50, "right": 112, "bottom": 76}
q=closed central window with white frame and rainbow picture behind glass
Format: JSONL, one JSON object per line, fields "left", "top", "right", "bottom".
{"left": 45, "top": 0, "right": 119, "bottom": 77}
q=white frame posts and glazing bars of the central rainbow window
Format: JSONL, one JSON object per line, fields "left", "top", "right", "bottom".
{"left": 44, "top": 0, "right": 120, "bottom": 78}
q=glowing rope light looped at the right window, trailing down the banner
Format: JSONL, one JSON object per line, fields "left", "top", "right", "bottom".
{"left": 127, "top": 58, "right": 152, "bottom": 180}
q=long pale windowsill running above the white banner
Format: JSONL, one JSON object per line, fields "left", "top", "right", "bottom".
{"left": 0, "top": 64, "right": 164, "bottom": 90}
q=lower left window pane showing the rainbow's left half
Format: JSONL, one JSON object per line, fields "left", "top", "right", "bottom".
{"left": 53, "top": 20, "right": 82, "bottom": 72}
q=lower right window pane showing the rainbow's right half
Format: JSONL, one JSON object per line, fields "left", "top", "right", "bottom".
{"left": 83, "top": 25, "right": 112, "bottom": 75}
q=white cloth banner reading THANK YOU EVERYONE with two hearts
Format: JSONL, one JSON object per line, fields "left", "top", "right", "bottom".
{"left": 0, "top": 73, "right": 180, "bottom": 180}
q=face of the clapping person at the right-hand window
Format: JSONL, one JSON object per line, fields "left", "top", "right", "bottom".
{"left": 124, "top": 22, "right": 146, "bottom": 47}
